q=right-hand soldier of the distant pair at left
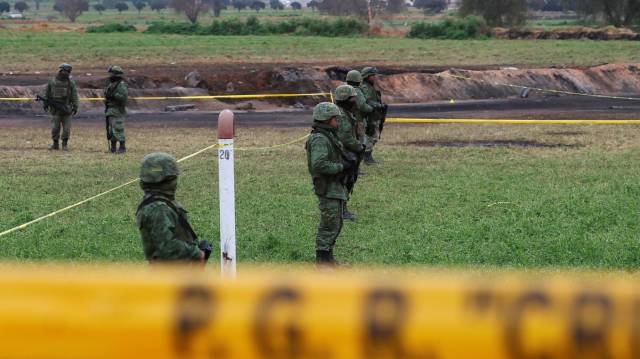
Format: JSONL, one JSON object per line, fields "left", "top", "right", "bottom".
{"left": 104, "top": 66, "right": 129, "bottom": 153}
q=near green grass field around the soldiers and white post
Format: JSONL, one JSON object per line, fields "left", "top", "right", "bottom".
{"left": 0, "top": 123, "right": 640, "bottom": 269}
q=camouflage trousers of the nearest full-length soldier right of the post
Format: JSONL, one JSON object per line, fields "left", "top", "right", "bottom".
{"left": 316, "top": 196, "right": 344, "bottom": 251}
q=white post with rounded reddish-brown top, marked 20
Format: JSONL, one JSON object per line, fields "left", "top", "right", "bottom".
{"left": 218, "top": 110, "right": 236, "bottom": 278}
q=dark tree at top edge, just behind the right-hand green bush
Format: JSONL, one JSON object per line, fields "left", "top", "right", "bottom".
{"left": 460, "top": 0, "right": 527, "bottom": 26}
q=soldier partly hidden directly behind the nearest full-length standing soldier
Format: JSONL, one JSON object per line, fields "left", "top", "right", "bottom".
{"left": 335, "top": 85, "right": 365, "bottom": 222}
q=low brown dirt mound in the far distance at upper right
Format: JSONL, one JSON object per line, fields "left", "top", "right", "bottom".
{"left": 494, "top": 27, "right": 640, "bottom": 41}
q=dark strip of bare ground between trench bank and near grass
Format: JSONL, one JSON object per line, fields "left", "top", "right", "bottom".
{"left": 0, "top": 96, "right": 640, "bottom": 128}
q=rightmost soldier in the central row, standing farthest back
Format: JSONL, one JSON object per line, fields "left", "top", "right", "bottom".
{"left": 360, "top": 67, "right": 387, "bottom": 165}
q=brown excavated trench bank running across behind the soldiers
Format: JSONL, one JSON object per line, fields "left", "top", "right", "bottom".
{"left": 0, "top": 64, "right": 640, "bottom": 114}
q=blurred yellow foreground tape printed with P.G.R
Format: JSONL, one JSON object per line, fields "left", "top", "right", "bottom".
{"left": 0, "top": 266, "right": 640, "bottom": 359}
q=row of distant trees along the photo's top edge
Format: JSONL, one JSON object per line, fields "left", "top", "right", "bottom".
{"left": 0, "top": 0, "right": 640, "bottom": 27}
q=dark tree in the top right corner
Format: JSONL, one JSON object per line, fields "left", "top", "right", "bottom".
{"left": 576, "top": 0, "right": 640, "bottom": 27}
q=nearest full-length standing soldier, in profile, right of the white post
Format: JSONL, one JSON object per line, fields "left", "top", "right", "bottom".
{"left": 305, "top": 102, "right": 354, "bottom": 265}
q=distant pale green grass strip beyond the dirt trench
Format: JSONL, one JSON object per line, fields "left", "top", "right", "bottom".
{"left": 0, "top": 31, "right": 640, "bottom": 72}
